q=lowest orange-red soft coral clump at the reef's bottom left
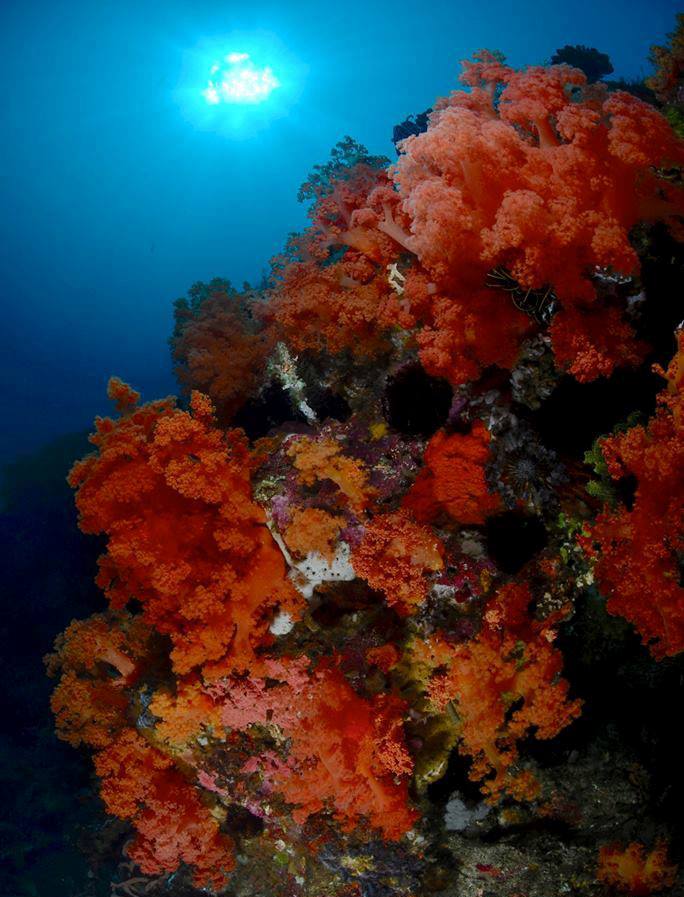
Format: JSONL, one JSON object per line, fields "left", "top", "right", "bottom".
{"left": 95, "top": 729, "right": 235, "bottom": 890}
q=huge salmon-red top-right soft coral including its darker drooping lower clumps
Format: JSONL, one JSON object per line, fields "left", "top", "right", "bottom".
{"left": 382, "top": 56, "right": 684, "bottom": 382}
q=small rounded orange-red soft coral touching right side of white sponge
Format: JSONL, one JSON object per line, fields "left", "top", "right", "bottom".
{"left": 352, "top": 511, "right": 443, "bottom": 615}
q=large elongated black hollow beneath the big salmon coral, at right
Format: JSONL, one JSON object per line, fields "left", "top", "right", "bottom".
{"left": 532, "top": 369, "right": 663, "bottom": 461}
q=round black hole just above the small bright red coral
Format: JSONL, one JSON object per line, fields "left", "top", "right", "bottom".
{"left": 383, "top": 364, "right": 453, "bottom": 436}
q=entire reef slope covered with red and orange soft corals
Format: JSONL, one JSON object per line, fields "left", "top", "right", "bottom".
{"left": 47, "top": 28, "right": 684, "bottom": 897}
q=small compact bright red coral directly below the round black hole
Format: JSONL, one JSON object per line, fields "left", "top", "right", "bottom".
{"left": 404, "top": 421, "right": 501, "bottom": 524}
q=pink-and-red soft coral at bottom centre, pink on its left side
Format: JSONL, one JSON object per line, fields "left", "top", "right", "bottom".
{"left": 214, "top": 662, "right": 416, "bottom": 840}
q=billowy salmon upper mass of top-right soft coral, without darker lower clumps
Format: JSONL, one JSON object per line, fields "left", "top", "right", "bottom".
{"left": 395, "top": 58, "right": 682, "bottom": 301}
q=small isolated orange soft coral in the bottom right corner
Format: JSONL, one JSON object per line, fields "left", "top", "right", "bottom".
{"left": 596, "top": 840, "right": 677, "bottom": 897}
